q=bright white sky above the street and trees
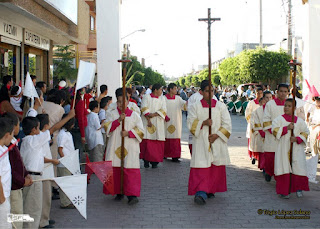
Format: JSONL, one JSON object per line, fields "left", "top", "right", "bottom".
{"left": 121, "top": 0, "right": 301, "bottom": 77}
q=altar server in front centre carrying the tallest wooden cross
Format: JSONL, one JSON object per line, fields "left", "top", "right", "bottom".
{"left": 187, "top": 80, "right": 231, "bottom": 205}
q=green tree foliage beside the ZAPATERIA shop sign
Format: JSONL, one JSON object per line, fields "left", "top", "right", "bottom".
{"left": 53, "top": 45, "right": 78, "bottom": 80}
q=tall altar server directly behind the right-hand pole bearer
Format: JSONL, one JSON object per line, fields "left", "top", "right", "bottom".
{"left": 263, "top": 84, "right": 289, "bottom": 182}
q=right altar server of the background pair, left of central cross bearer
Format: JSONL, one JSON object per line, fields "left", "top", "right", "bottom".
{"left": 164, "top": 83, "right": 187, "bottom": 162}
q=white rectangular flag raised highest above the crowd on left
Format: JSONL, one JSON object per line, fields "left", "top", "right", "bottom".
{"left": 76, "top": 60, "right": 96, "bottom": 91}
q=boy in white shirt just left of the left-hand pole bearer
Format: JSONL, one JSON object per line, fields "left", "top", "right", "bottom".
{"left": 86, "top": 101, "right": 104, "bottom": 162}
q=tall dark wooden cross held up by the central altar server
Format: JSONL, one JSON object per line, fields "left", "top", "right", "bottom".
{"left": 198, "top": 8, "right": 221, "bottom": 135}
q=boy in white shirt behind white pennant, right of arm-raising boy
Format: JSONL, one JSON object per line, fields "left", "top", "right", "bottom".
{"left": 57, "top": 114, "right": 75, "bottom": 209}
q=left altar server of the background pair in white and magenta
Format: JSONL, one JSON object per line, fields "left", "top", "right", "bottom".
{"left": 140, "top": 84, "right": 167, "bottom": 168}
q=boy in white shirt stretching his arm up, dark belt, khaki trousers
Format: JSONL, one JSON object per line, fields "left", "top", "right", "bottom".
{"left": 20, "top": 110, "right": 75, "bottom": 228}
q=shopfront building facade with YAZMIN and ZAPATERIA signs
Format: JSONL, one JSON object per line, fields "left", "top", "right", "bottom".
{"left": 0, "top": 0, "right": 90, "bottom": 87}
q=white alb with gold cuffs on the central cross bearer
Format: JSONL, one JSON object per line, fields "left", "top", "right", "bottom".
{"left": 187, "top": 101, "right": 231, "bottom": 168}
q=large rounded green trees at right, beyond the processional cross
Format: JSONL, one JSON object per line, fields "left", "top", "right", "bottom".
{"left": 219, "top": 47, "right": 291, "bottom": 85}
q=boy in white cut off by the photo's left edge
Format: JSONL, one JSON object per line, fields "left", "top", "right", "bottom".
{"left": 0, "top": 118, "right": 13, "bottom": 228}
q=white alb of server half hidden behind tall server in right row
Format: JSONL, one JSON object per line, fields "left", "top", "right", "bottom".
{"left": 250, "top": 106, "right": 264, "bottom": 153}
